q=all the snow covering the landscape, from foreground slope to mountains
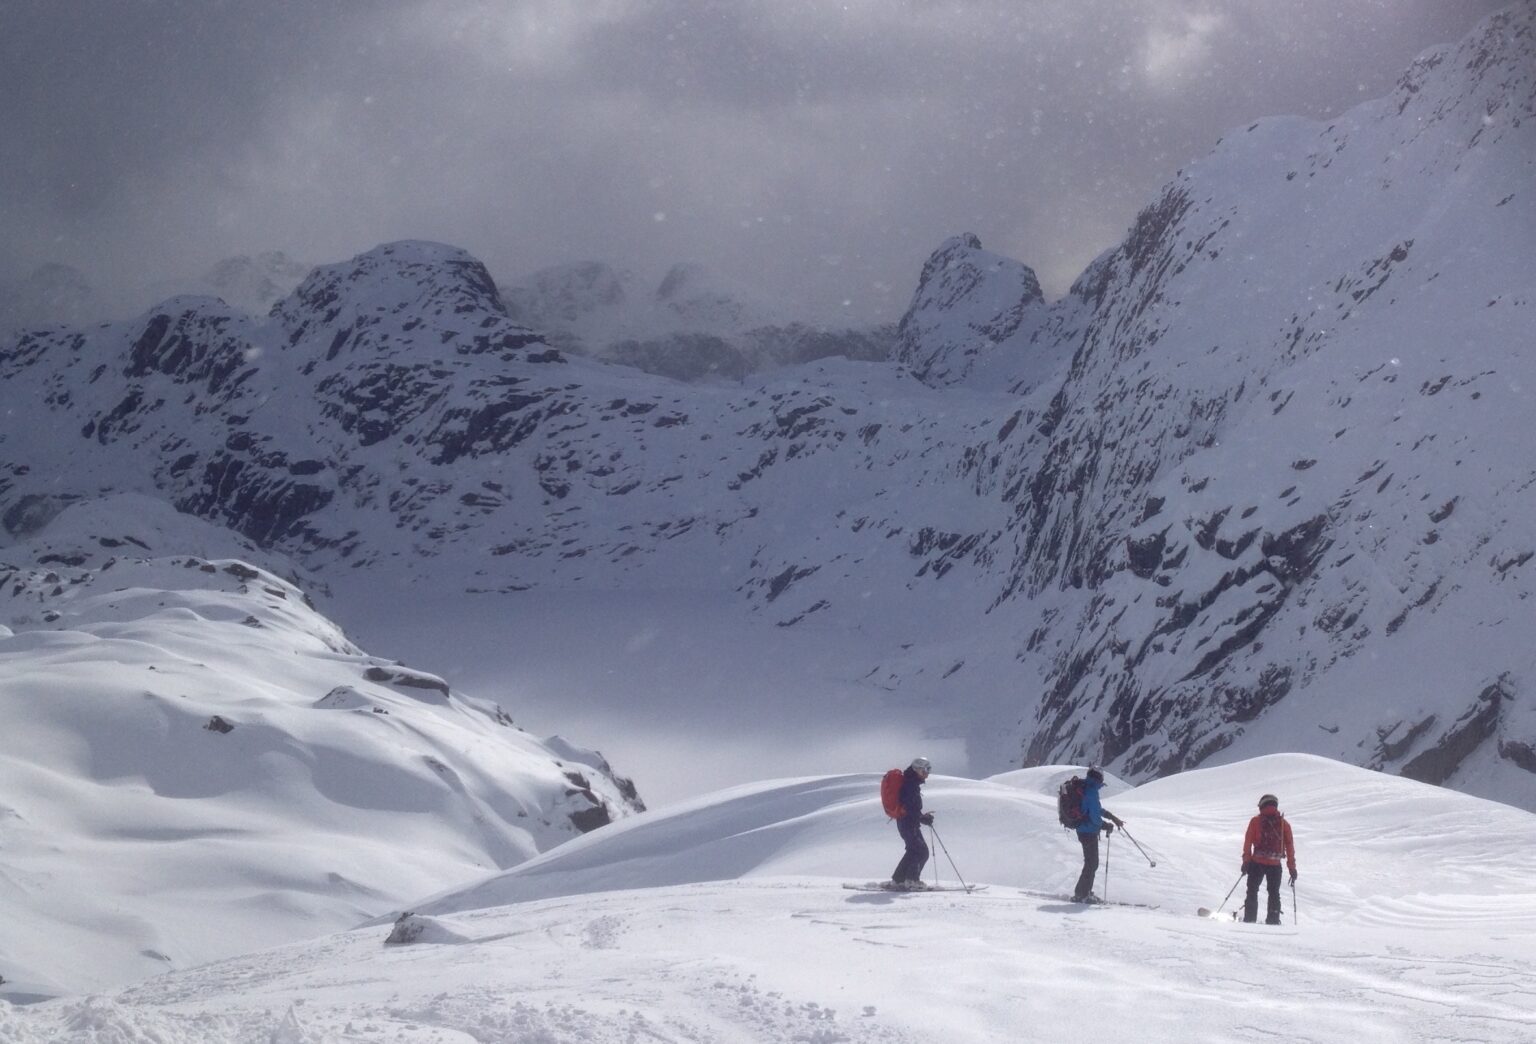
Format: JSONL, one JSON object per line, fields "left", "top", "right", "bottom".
{"left": 0, "top": 6, "right": 1536, "bottom": 1044}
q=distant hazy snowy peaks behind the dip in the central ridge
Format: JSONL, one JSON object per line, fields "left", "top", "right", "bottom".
{"left": 501, "top": 261, "right": 895, "bottom": 382}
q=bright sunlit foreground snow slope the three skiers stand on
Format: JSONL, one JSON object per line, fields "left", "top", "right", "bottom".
{"left": 0, "top": 754, "right": 1536, "bottom": 1044}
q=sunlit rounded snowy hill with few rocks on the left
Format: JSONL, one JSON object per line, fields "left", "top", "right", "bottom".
{"left": 0, "top": 496, "right": 642, "bottom": 995}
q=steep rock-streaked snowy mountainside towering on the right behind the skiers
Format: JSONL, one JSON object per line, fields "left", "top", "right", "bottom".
{"left": 976, "top": 6, "right": 1536, "bottom": 803}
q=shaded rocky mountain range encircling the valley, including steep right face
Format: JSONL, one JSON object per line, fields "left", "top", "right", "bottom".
{"left": 9, "top": 5, "right": 1536, "bottom": 808}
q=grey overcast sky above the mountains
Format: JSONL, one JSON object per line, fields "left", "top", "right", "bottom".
{"left": 0, "top": 0, "right": 1508, "bottom": 319}
